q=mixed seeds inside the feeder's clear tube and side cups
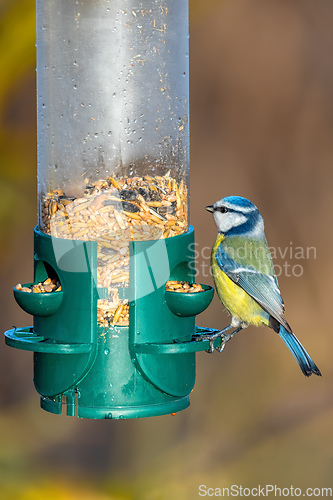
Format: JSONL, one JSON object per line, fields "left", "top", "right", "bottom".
{"left": 39, "top": 171, "right": 187, "bottom": 327}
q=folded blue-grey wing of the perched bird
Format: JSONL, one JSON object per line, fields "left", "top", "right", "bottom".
{"left": 216, "top": 240, "right": 290, "bottom": 331}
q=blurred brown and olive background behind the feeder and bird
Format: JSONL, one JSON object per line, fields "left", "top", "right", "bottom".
{"left": 0, "top": 0, "right": 333, "bottom": 500}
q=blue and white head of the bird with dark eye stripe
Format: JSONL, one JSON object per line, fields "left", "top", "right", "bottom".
{"left": 206, "top": 196, "right": 264, "bottom": 238}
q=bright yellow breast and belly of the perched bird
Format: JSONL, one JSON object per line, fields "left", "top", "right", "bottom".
{"left": 211, "top": 234, "right": 268, "bottom": 326}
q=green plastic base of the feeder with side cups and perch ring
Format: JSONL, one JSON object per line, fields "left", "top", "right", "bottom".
{"left": 5, "top": 228, "right": 219, "bottom": 419}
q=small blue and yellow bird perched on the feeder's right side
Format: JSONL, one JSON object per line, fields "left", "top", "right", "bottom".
{"left": 201, "top": 196, "right": 321, "bottom": 377}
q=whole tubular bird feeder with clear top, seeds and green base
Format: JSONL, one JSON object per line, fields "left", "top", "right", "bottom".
{"left": 5, "top": 0, "right": 220, "bottom": 419}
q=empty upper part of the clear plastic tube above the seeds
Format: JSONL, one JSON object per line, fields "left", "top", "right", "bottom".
{"left": 37, "top": 0, "right": 189, "bottom": 196}
